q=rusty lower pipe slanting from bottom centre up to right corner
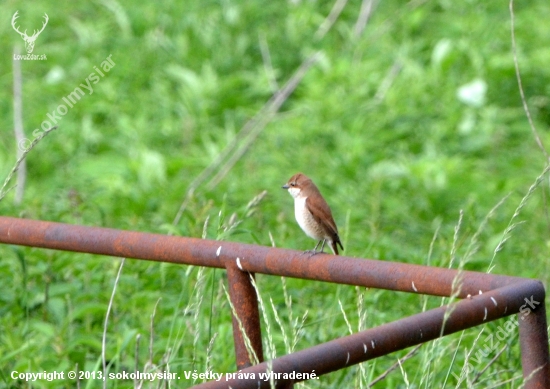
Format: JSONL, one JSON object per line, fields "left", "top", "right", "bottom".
{"left": 193, "top": 280, "right": 550, "bottom": 389}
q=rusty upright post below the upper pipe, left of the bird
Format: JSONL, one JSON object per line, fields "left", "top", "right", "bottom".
{"left": 226, "top": 262, "right": 264, "bottom": 370}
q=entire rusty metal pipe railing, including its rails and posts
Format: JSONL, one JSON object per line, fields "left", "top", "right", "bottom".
{"left": 0, "top": 217, "right": 550, "bottom": 389}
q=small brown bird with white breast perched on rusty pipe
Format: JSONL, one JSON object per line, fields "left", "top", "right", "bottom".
{"left": 283, "top": 173, "right": 344, "bottom": 255}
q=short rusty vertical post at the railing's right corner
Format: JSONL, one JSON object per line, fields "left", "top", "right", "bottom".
{"left": 518, "top": 304, "right": 550, "bottom": 389}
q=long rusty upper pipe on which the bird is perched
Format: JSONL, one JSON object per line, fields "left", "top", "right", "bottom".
{"left": 0, "top": 217, "right": 523, "bottom": 298}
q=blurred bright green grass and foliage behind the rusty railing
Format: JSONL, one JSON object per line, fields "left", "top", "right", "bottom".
{"left": 0, "top": 0, "right": 550, "bottom": 388}
